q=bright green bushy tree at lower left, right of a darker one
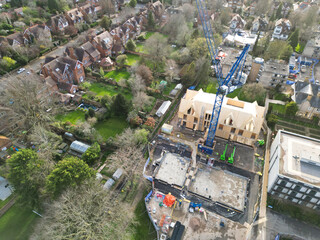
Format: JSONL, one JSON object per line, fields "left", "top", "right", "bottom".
{"left": 46, "top": 157, "right": 95, "bottom": 198}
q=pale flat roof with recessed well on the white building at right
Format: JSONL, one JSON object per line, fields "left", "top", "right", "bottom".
{"left": 280, "top": 131, "right": 320, "bottom": 186}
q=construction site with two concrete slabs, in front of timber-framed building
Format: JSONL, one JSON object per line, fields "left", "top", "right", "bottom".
{"left": 144, "top": 124, "right": 264, "bottom": 240}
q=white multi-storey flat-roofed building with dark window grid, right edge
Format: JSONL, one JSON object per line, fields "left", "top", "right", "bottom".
{"left": 268, "top": 130, "right": 320, "bottom": 210}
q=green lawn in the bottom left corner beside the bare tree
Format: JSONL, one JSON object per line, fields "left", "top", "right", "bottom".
{"left": 0, "top": 204, "right": 39, "bottom": 240}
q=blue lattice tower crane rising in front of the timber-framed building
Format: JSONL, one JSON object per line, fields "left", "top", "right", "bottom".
{"left": 196, "top": 0, "right": 250, "bottom": 154}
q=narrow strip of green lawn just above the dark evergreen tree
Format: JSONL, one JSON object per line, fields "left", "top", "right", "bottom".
{"left": 85, "top": 83, "right": 132, "bottom": 100}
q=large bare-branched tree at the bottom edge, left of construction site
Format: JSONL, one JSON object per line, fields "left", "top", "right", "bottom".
{"left": 31, "top": 179, "right": 133, "bottom": 240}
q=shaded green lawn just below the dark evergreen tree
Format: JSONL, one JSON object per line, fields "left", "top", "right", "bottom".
{"left": 94, "top": 117, "right": 128, "bottom": 140}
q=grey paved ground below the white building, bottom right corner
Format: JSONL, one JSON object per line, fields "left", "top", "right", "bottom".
{"left": 255, "top": 208, "right": 320, "bottom": 240}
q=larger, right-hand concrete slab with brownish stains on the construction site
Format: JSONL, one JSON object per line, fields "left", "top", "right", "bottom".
{"left": 189, "top": 168, "right": 248, "bottom": 211}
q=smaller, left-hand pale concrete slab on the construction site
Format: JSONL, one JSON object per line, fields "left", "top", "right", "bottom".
{"left": 155, "top": 152, "right": 190, "bottom": 187}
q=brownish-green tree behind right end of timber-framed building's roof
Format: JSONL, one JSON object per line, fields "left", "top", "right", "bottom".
{"left": 239, "top": 83, "right": 266, "bottom": 106}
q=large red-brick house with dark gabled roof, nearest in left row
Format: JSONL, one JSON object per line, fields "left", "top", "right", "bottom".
{"left": 41, "top": 57, "right": 85, "bottom": 93}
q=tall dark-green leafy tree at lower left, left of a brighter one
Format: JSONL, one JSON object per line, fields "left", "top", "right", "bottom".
{"left": 7, "top": 149, "right": 47, "bottom": 207}
